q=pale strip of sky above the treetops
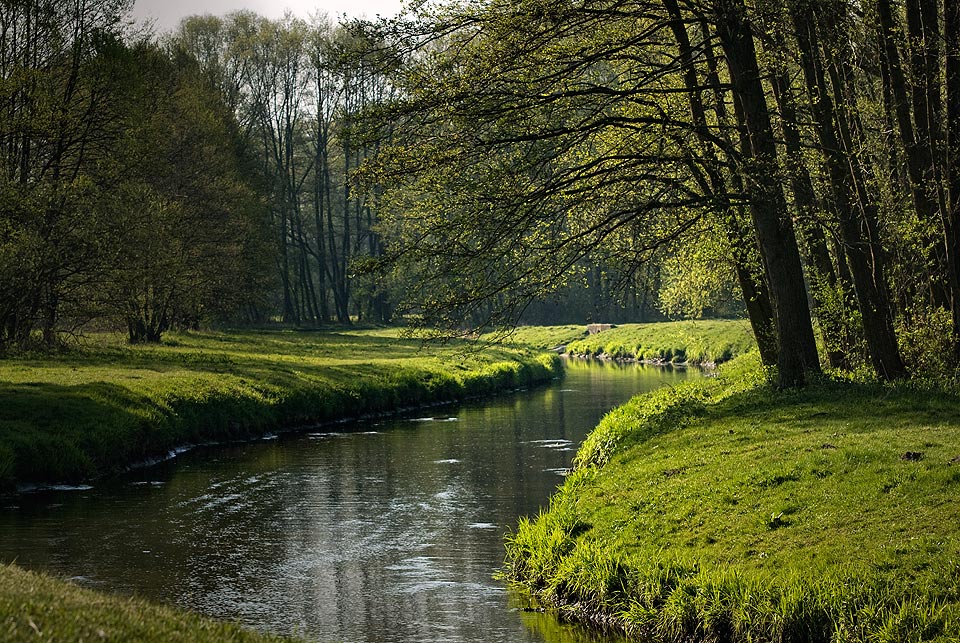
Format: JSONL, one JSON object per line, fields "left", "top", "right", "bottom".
{"left": 133, "top": 0, "right": 402, "bottom": 33}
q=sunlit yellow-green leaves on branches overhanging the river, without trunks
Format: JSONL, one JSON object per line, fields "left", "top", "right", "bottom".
{"left": 368, "top": 2, "right": 709, "bottom": 338}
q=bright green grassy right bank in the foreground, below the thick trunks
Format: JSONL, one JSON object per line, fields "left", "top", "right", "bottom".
{"left": 506, "top": 357, "right": 960, "bottom": 643}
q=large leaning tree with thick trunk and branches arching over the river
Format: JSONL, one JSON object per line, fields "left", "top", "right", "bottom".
{"left": 368, "top": 1, "right": 819, "bottom": 386}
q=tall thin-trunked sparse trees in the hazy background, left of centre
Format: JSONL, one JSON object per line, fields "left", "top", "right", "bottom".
{"left": 173, "top": 12, "right": 393, "bottom": 324}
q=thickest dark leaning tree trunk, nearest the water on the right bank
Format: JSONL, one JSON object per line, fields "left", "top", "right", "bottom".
{"left": 713, "top": 0, "right": 820, "bottom": 387}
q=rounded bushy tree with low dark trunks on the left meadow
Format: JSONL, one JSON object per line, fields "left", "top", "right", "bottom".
{"left": 104, "top": 43, "right": 266, "bottom": 343}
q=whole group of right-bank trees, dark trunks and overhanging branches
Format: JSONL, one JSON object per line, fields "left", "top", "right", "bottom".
{"left": 368, "top": 0, "right": 960, "bottom": 386}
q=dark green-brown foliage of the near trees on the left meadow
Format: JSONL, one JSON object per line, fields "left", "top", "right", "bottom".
{"left": 0, "top": 0, "right": 272, "bottom": 350}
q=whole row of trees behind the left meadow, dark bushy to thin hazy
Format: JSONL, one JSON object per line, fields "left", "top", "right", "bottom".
{"left": 0, "top": 0, "right": 392, "bottom": 349}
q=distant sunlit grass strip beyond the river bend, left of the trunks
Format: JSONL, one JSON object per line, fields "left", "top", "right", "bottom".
{"left": 567, "top": 319, "right": 756, "bottom": 364}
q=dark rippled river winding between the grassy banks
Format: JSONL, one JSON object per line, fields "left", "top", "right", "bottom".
{"left": 0, "top": 362, "right": 688, "bottom": 643}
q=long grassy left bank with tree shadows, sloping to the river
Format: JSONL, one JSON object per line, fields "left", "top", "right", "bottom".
{"left": 0, "top": 331, "right": 559, "bottom": 489}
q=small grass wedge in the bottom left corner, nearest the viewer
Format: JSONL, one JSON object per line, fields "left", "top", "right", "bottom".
{"left": 0, "top": 565, "right": 292, "bottom": 643}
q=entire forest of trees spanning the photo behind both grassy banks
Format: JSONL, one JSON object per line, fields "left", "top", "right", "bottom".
{"left": 0, "top": 0, "right": 960, "bottom": 387}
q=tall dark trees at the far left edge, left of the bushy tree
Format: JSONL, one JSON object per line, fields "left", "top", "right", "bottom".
{"left": 0, "top": 0, "right": 133, "bottom": 347}
